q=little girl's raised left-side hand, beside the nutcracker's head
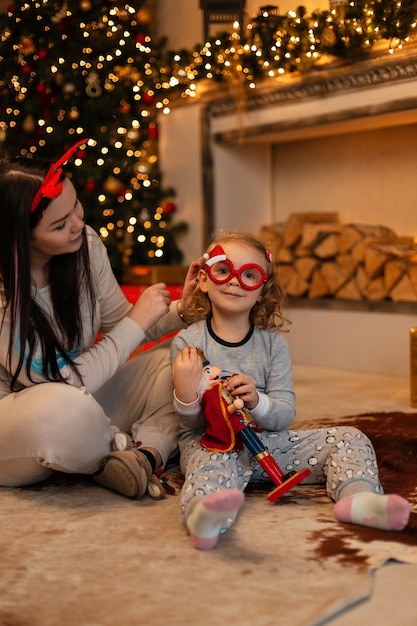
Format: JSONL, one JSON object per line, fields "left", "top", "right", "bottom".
{"left": 172, "top": 346, "right": 203, "bottom": 404}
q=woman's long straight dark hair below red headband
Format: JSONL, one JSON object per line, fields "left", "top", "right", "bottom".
{"left": 0, "top": 157, "right": 96, "bottom": 391}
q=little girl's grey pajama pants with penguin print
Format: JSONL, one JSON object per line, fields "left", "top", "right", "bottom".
{"left": 180, "top": 426, "right": 383, "bottom": 521}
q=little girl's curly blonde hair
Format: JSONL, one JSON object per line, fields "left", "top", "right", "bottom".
{"left": 182, "top": 230, "right": 290, "bottom": 332}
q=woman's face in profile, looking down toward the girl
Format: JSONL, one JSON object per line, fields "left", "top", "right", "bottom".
{"left": 30, "top": 178, "right": 84, "bottom": 262}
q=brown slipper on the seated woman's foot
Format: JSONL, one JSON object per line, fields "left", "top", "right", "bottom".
{"left": 93, "top": 448, "right": 152, "bottom": 500}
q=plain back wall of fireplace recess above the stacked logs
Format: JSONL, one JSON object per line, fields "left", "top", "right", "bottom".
{"left": 272, "top": 125, "right": 417, "bottom": 236}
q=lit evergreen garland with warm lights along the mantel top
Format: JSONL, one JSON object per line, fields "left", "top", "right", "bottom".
{"left": 167, "top": 0, "right": 417, "bottom": 97}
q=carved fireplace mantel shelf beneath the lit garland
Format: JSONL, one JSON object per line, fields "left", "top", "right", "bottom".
{"left": 208, "top": 45, "right": 417, "bottom": 145}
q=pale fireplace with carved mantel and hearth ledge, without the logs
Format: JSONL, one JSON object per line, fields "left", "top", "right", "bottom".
{"left": 161, "top": 44, "right": 417, "bottom": 376}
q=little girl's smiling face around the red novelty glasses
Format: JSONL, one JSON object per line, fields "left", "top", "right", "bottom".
{"left": 199, "top": 241, "right": 267, "bottom": 314}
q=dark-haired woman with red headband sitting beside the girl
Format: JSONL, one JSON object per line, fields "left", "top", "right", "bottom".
{"left": 0, "top": 140, "right": 198, "bottom": 498}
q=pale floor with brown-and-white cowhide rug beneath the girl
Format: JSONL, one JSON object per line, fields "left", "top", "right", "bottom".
{"left": 0, "top": 368, "right": 417, "bottom": 626}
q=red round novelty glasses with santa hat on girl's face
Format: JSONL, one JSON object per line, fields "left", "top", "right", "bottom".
{"left": 204, "top": 246, "right": 270, "bottom": 291}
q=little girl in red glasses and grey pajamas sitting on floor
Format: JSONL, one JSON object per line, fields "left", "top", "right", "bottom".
{"left": 171, "top": 232, "right": 410, "bottom": 550}
